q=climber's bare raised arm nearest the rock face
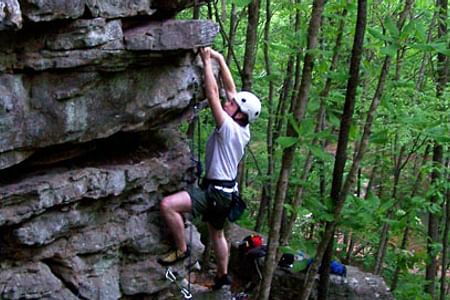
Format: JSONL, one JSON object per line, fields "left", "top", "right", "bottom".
{"left": 200, "top": 47, "right": 226, "bottom": 127}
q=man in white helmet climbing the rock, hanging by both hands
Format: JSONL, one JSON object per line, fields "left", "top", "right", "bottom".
{"left": 158, "top": 47, "right": 261, "bottom": 289}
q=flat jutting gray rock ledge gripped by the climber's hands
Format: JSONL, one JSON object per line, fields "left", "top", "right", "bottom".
{"left": 0, "top": 18, "right": 219, "bottom": 73}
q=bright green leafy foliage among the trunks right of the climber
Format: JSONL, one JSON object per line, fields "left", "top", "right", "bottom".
{"left": 189, "top": 0, "right": 450, "bottom": 299}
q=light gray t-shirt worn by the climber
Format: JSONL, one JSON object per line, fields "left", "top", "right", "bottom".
{"left": 206, "top": 115, "right": 250, "bottom": 180}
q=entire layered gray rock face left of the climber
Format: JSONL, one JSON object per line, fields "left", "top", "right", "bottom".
{"left": 0, "top": 0, "right": 218, "bottom": 299}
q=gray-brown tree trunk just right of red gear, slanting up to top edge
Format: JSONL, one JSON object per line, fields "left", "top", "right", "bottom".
{"left": 258, "top": 0, "right": 325, "bottom": 300}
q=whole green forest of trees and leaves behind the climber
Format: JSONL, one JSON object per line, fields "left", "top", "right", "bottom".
{"left": 178, "top": 0, "right": 450, "bottom": 300}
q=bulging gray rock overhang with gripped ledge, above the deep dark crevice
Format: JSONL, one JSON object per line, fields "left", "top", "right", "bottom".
{"left": 0, "top": 18, "right": 218, "bottom": 169}
